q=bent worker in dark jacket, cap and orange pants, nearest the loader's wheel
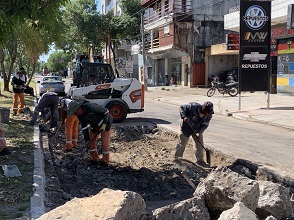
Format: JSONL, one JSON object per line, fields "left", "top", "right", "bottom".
{"left": 67, "top": 99, "right": 113, "bottom": 166}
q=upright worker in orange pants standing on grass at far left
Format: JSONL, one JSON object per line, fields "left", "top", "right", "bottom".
{"left": 11, "top": 67, "right": 27, "bottom": 116}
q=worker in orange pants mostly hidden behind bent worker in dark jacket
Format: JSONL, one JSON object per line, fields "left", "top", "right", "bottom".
{"left": 60, "top": 98, "right": 79, "bottom": 151}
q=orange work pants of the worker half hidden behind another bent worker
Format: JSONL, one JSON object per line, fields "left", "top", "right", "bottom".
{"left": 65, "top": 115, "right": 79, "bottom": 150}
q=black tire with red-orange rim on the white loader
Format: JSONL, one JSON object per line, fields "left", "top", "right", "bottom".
{"left": 106, "top": 101, "right": 128, "bottom": 123}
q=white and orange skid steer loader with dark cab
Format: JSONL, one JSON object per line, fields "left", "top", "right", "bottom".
{"left": 68, "top": 46, "right": 144, "bottom": 123}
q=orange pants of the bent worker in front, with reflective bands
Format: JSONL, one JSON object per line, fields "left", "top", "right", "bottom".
{"left": 89, "top": 130, "right": 110, "bottom": 165}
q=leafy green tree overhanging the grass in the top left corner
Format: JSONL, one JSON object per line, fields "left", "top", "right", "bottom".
{"left": 0, "top": 0, "right": 67, "bottom": 90}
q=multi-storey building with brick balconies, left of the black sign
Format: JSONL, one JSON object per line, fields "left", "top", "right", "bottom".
{"left": 142, "top": 0, "right": 238, "bottom": 87}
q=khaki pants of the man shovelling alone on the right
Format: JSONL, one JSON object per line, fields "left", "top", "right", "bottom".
{"left": 175, "top": 131, "right": 204, "bottom": 163}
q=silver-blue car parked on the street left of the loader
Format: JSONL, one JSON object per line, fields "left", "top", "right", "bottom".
{"left": 37, "top": 76, "right": 65, "bottom": 96}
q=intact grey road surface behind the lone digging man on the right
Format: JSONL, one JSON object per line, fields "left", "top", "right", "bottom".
{"left": 126, "top": 97, "right": 294, "bottom": 179}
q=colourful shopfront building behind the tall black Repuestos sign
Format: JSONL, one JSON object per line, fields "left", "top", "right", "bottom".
{"left": 224, "top": 0, "right": 294, "bottom": 95}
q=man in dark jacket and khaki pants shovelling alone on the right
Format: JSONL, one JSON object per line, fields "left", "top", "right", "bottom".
{"left": 175, "top": 101, "right": 214, "bottom": 166}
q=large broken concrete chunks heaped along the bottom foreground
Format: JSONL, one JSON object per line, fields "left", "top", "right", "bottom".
{"left": 38, "top": 166, "right": 293, "bottom": 220}
